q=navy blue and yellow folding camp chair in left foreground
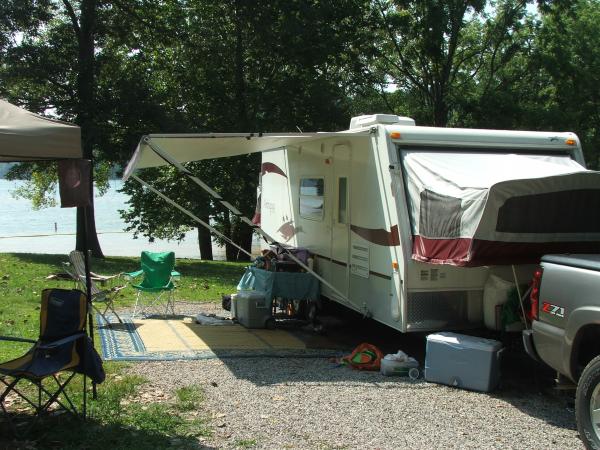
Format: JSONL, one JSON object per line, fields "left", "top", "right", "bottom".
{"left": 0, "top": 289, "right": 104, "bottom": 435}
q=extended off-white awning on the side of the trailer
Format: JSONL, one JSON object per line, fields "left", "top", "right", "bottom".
{"left": 123, "top": 131, "right": 368, "bottom": 180}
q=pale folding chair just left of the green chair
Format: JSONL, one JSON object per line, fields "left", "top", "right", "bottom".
{"left": 65, "top": 250, "right": 127, "bottom": 326}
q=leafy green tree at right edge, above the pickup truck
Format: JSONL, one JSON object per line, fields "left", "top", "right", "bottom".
{"left": 532, "top": 0, "right": 600, "bottom": 169}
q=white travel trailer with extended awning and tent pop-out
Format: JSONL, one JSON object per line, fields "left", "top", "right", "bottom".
{"left": 126, "top": 114, "right": 600, "bottom": 332}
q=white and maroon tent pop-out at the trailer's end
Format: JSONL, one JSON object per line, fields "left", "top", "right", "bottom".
{"left": 402, "top": 150, "right": 600, "bottom": 266}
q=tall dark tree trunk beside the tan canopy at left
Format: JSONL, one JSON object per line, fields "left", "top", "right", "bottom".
{"left": 73, "top": 0, "right": 104, "bottom": 258}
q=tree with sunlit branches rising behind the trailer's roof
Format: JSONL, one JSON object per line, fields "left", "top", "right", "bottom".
{"left": 372, "top": 0, "right": 556, "bottom": 126}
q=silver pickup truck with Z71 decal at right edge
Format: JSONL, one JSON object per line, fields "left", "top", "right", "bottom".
{"left": 523, "top": 255, "right": 600, "bottom": 449}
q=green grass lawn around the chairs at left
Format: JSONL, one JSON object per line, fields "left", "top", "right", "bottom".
{"left": 0, "top": 254, "right": 247, "bottom": 449}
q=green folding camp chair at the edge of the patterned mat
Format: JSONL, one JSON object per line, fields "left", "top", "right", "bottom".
{"left": 124, "top": 251, "right": 180, "bottom": 318}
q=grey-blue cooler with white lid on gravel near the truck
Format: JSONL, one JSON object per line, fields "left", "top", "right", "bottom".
{"left": 425, "top": 332, "right": 502, "bottom": 392}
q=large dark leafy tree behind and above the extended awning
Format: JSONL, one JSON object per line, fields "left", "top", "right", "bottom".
{"left": 116, "top": 0, "right": 376, "bottom": 259}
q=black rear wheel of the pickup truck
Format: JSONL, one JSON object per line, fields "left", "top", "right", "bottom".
{"left": 575, "top": 356, "right": 600, "bottom": 449}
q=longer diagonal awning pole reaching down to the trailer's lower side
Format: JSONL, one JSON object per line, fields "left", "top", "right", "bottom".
{"left": 139, "top": 136, "right": 356, "bottom": 308}
